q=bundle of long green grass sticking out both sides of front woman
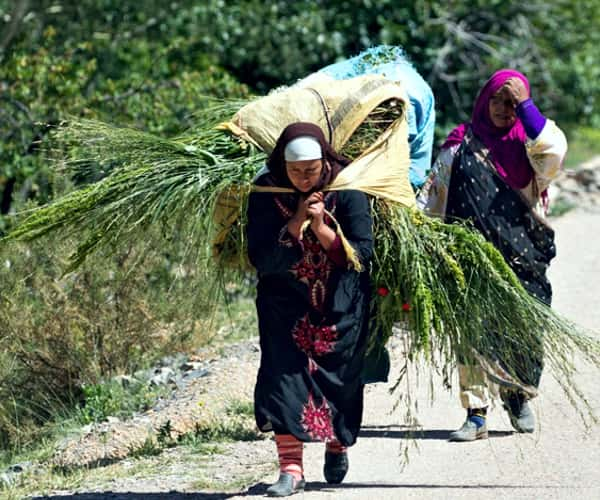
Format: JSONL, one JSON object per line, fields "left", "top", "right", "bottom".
{"left": 8, "top": 101, "right": 600, "bottom": 426}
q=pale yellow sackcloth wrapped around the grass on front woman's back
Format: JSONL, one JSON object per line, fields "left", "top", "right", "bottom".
{"left": 213, "top": 75, "right": 415, "bottom": 268}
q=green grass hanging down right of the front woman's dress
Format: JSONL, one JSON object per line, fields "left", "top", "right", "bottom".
{"left": 372, "top": 200, "right": 600, "bottom": 421}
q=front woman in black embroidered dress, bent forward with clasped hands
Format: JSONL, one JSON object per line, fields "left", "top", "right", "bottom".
{"left": 247, "top": 123, "right": 373, "bottom": 496}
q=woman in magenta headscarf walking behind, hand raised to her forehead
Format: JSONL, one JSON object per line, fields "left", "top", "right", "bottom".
{"left": 418, "top": 69, "right": 567, "bottom": 441}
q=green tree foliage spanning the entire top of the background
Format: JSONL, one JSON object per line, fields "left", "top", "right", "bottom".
{"left": 0, "top": 0, "right": 600, "bottom": 223}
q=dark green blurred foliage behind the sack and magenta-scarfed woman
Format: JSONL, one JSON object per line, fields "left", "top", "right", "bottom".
{"left": 184, "top": 0, "right": 600, "bottom": 131}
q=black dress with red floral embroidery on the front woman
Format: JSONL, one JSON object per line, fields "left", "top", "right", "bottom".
{"left": 247, "top": 187, "right": 372, "bottom": 446}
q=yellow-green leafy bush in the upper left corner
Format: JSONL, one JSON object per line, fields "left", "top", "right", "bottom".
{"left": 0, "top": 0, "right": 248, "bottom": 227}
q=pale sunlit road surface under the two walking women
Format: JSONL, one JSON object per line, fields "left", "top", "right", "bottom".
{"left": 238, "top": 211, "right": 600, "bottom": 500}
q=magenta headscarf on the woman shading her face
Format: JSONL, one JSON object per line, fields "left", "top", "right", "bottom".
{"left": 442, "top": 69, "right": 533, "bottom": 189}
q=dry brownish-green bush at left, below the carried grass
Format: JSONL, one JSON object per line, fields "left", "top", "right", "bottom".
{"left": 0, "top": 232, "right": 223, "bottom": 447}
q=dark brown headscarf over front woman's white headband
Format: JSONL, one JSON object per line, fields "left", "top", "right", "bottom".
{"left": 257, "top": 122, "right": 350, "bottom": 192}
